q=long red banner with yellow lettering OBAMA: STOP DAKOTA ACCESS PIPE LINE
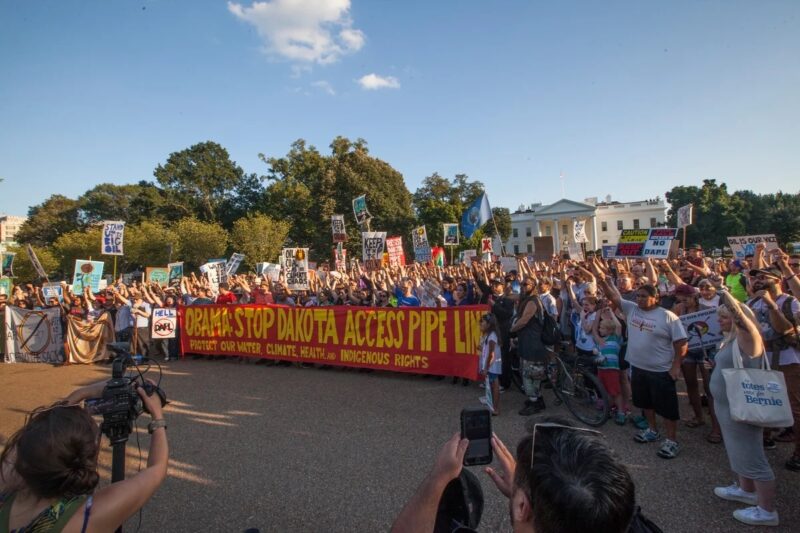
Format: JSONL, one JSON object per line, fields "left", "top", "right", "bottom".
{"left": 178, "top": 304, "right": 487, "bottom": 379}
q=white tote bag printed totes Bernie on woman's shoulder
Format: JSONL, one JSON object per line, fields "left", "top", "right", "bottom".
{"left": 722, "top": 341, "right": 794, "bottom": 428}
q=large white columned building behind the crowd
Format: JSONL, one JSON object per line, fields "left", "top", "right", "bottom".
{"left": 506, "top": 196, "right": 667, "bottom": 255}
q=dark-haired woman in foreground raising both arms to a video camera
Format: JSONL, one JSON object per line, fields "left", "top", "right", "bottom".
{"left": 0, "top": 381, "right": 168, "bottom": 533}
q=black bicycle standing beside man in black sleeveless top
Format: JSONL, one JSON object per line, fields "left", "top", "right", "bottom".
{"left": 509, "top": 342, "right": 611, "bottom": 427}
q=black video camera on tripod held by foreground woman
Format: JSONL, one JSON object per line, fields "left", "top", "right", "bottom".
{"left": 86, "top": 342, "right": 167, "bottom": 444}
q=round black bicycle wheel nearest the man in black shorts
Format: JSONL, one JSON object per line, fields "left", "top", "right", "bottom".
{"left": 557, "top": 367, "right": 611, "bottom": 426}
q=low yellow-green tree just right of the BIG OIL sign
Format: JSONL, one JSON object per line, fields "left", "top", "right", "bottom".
{"left": 123, "top": 220, "right": 179, "bottom": 270}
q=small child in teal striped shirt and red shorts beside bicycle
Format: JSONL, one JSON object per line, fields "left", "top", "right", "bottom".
{"left": 592, "top": 307, "right": 629, "bottom": 426}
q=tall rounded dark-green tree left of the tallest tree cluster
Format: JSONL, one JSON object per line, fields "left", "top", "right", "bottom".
{"left": 153, "top": 141, "right": 244, "bottom": 222}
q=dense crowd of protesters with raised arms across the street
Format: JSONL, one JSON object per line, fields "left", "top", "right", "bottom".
{"left": 0, "top": 245, "right": 800, "bottom": 525}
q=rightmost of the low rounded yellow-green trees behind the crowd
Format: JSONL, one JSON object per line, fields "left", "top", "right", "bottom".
{"left": 231, "top": 214, "right": 291, "bottom": 266}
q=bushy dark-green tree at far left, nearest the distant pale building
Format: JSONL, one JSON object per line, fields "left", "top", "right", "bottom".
{"left": 16, "top": 194, "right": 83, "bottom": 246}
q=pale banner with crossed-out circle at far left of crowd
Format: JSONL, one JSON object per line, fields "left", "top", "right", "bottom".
{"left": 0, "top": 305, "right": 64, "bottom": 363}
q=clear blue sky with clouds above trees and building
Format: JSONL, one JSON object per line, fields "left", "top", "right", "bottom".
{"left": 0, "top": 0, "right": 800, "bottom": 214}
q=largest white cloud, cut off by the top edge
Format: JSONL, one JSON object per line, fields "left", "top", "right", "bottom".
{"left": 228, "top": 0, "right": 366, "bottom": 65}
